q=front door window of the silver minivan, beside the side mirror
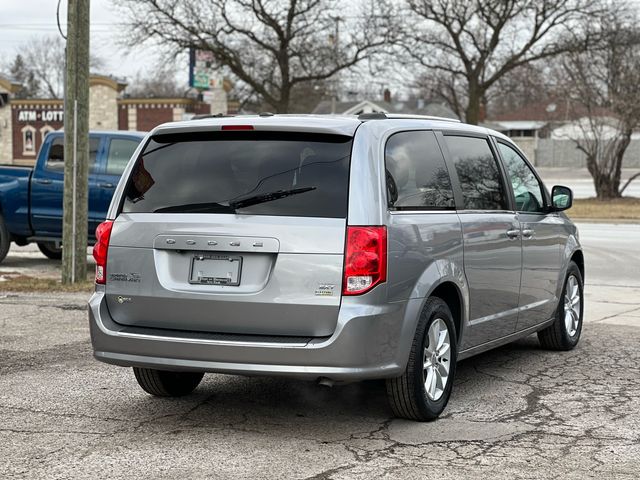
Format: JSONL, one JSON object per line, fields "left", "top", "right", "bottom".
{"left": 498, "top": 143, "right": 544, "bottom": 212}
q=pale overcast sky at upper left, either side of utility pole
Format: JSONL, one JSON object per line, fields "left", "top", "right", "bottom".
{"left": 0, "top": 0, "right": 172, "bottom": 83}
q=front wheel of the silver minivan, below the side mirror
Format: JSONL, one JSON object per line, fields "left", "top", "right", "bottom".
{"left": 538, "top": 262, "right": 584, "bottom": 351}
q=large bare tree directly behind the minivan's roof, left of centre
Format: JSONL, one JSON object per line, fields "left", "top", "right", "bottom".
{"left": 115, "top": 0, "right": 391, "bottom": 113}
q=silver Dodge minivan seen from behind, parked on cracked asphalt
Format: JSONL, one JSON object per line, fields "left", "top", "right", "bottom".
{"left": 89, "top": 114, "right": 584, "bottom": 420}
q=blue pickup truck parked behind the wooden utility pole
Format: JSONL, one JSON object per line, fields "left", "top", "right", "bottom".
{"left": 0, "top": 131, "right": 145, "bottom": 262}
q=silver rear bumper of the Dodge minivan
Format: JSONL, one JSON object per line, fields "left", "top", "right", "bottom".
{"left": 89, "top": 292, "right": 421, "bottom": 381}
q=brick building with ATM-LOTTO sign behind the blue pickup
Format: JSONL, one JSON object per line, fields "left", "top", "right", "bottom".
{"left": 0, "top": 75, "right": 227, "bottom": 165}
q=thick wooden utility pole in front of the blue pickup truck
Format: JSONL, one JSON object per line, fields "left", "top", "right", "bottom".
{"left": 62, "top": 0, "right": 90, "bottom": 284}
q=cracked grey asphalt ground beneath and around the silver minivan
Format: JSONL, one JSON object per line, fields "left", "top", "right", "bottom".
{"left": 0, "top": 224, "right": 640, "bottom": 480}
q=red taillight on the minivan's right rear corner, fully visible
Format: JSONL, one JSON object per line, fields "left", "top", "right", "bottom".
{"left": 342, "top": 227, "right": 387, "bottom": 295}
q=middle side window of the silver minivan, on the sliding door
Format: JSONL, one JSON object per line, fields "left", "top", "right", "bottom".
{"left": 444, "top": 135, "right": 508, "bottom": 210}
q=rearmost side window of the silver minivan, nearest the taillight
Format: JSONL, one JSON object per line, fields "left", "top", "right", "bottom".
{"left": 385, "top": 131, "right": 455, "bottom": 209}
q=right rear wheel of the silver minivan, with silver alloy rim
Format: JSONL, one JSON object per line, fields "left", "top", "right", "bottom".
{"left": 386, "top": 297, "right": 458, "bottom": 421}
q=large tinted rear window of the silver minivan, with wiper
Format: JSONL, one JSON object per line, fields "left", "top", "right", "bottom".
{"left": 122, "top": 131, "right": 352, "bottom": 218}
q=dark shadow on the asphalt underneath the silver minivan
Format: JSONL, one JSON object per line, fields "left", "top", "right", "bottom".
{"left": 117, "top": 336, "right": 549, "bottom": 428}
